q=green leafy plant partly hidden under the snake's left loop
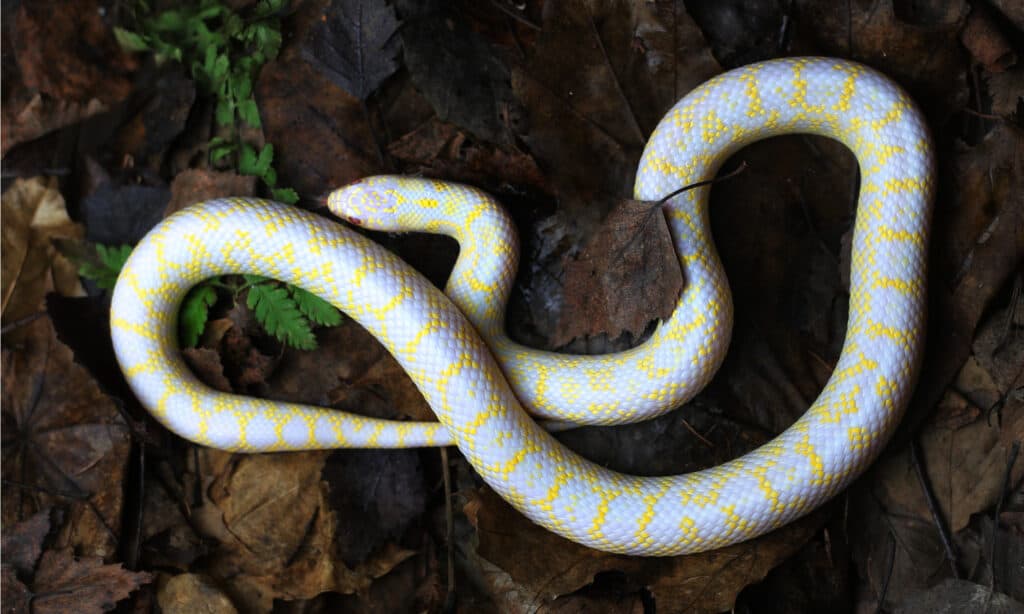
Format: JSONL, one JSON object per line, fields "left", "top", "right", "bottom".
{"left": 90, "top": 0, "right": 341, "bottom": 349}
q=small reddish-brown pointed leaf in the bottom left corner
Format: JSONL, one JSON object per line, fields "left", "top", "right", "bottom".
{"left": 32, "top": 549, "right": 153, "bottom": 614}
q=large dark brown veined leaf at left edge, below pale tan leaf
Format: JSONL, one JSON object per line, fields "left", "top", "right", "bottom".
{"left": 2, "top": 317, "right": 130, "bottom": 557}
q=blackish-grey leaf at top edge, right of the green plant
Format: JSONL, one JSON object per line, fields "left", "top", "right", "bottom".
{"left": 303, "top": 0, "right": 400, "bottom": 100}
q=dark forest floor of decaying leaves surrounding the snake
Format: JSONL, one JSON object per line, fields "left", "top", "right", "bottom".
{"left": 2, "top": 0, "right": 1024, "bottom": 614}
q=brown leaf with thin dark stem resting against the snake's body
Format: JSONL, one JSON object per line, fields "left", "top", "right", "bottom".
{"left": 551, "top": 201, "right": 683, "bottom": 346}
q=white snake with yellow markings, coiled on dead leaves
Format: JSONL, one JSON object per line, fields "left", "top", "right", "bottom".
{"left": 110, "top": 57, "right": 935, "bottom": 556}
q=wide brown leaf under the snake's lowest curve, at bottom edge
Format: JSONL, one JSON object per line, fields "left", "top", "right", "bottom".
{"left": 466, "top": 489, "right": 824, "bottom": 613}
